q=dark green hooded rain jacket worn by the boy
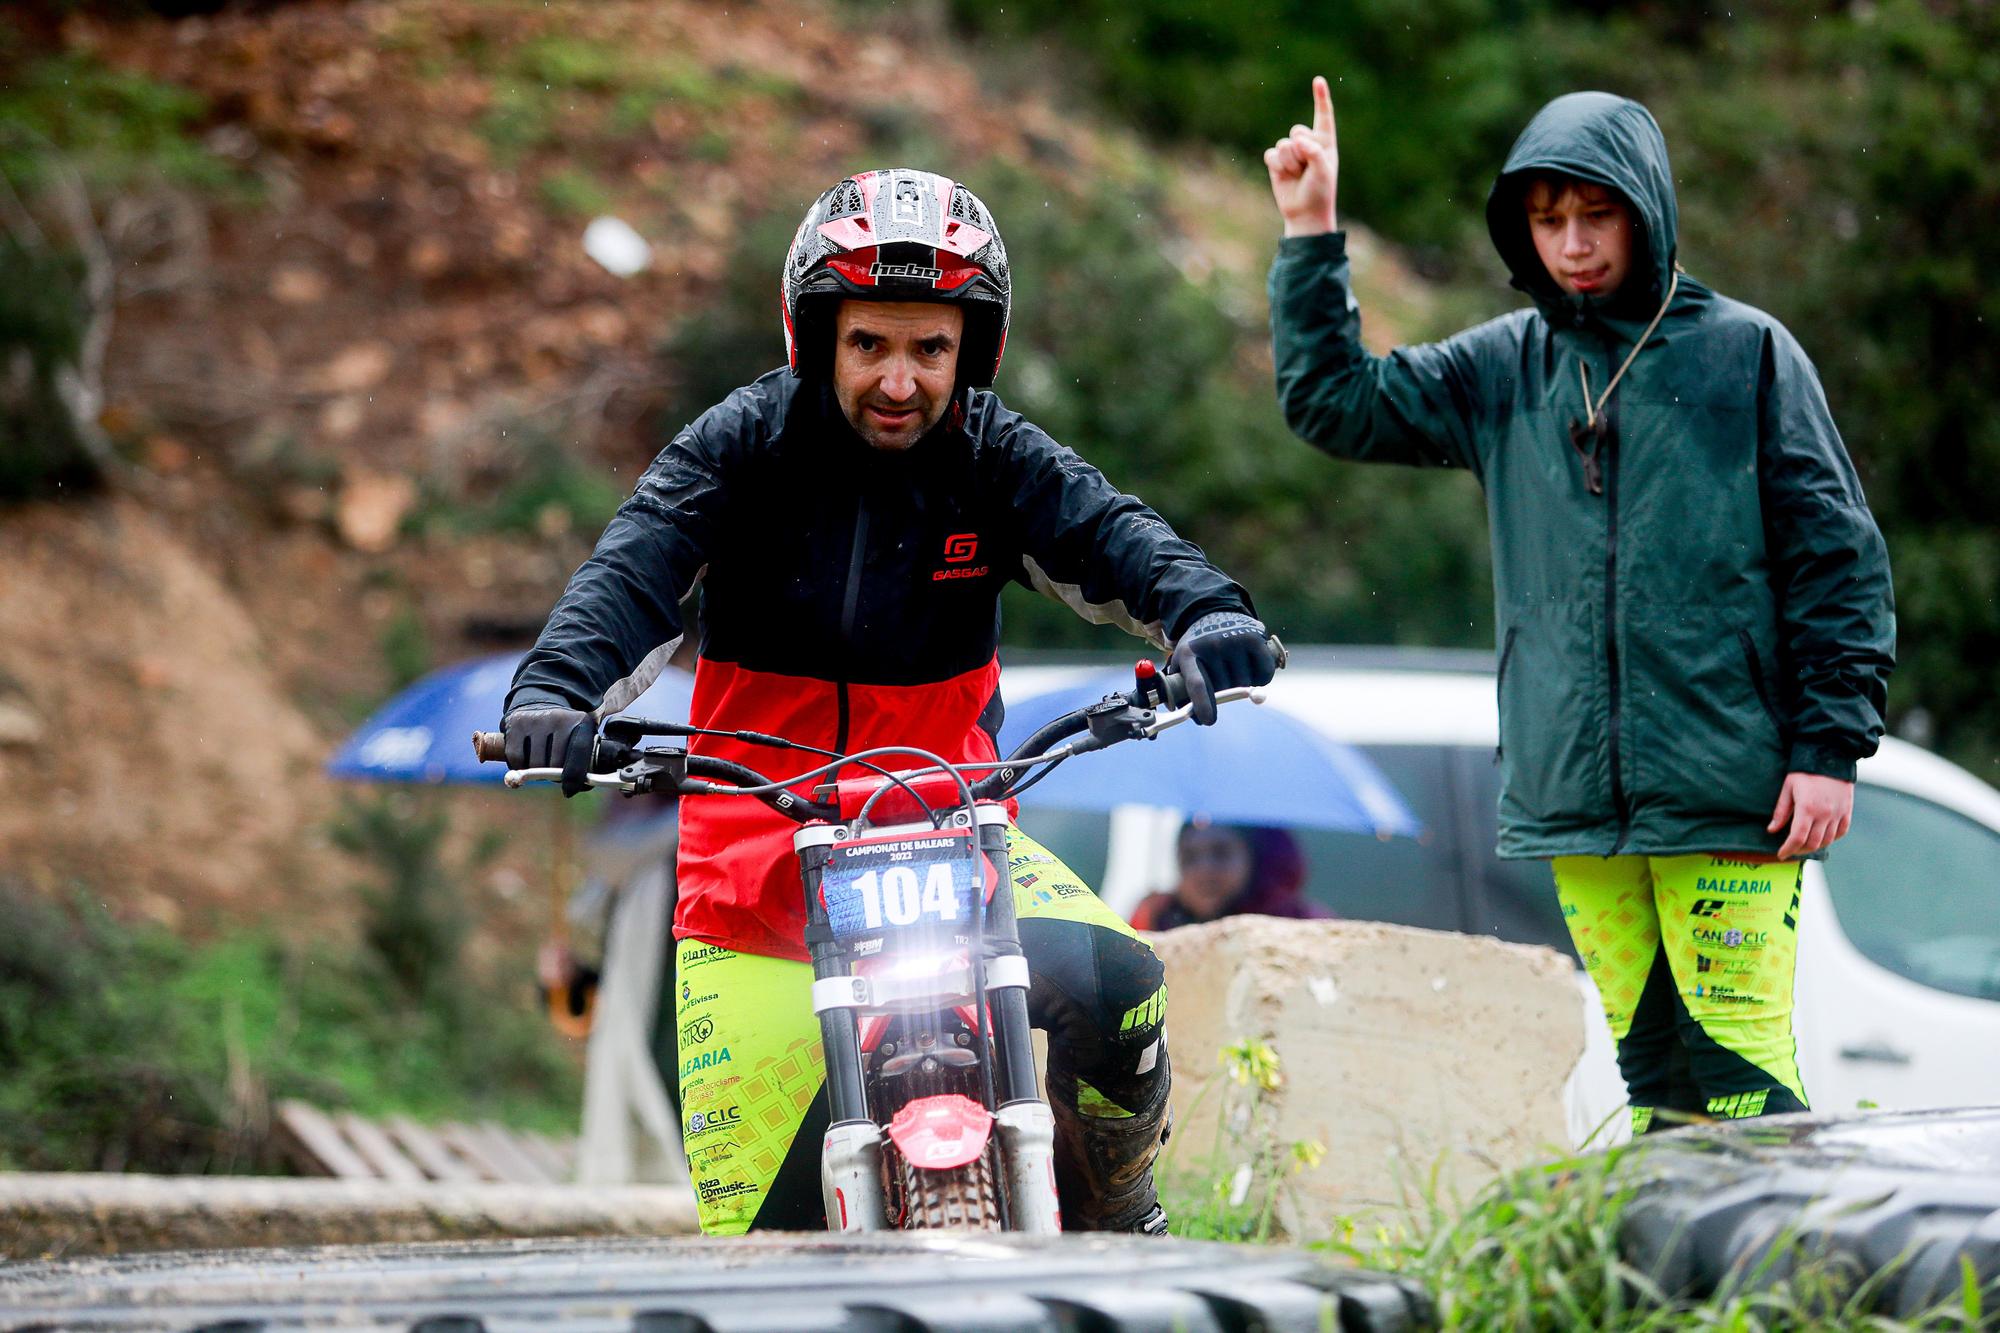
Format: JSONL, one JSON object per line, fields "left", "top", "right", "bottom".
{"left": 1270, "top": 92, "right": 1896, "bottom": 857}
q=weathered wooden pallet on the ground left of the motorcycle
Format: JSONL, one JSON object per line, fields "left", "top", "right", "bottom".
{"left": 276, "top": 1101, "right": 576, "bottom": 1185}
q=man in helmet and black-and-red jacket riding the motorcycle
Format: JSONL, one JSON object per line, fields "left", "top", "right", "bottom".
{"left": 504, "top": 170, "right": 1276, "bottom": 1233}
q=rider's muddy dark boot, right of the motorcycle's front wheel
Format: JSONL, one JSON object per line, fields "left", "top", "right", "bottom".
{"left": 1048, "top": 1043, "right": 1174, "bottom": 1235}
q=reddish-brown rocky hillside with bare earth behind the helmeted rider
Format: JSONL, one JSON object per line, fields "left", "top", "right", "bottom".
{"left": 0, "top": 0, "right": 1426, "bottom": 927}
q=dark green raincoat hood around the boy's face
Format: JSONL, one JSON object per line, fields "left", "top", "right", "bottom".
{"left": 1486, "top": 92, "right": 1680, "bottom": 318}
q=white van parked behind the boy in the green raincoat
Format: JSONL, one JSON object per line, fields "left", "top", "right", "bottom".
{"left": 1002, "top": 648, "right": 2000, "bottom": 1143}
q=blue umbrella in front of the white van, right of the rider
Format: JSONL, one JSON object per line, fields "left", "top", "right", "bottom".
{"left": 1000, "top": 675, "right": 1422, "bottom": 837}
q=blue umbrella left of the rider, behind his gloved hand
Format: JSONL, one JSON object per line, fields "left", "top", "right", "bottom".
{"left": 326, "top": 652, "right": 694, "bottom": 785}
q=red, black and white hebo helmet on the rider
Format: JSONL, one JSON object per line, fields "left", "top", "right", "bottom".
{"left": 784, "top": 166, "right": 1014, "bottom": 388}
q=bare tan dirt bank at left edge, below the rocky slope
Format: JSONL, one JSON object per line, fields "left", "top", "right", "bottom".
{"left": 0, "top": 500, "right": 340, "bottom": 925}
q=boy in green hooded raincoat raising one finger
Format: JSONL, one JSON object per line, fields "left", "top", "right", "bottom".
{"left": 1264, "top": 78, "right": 1896, "bottom": 1133}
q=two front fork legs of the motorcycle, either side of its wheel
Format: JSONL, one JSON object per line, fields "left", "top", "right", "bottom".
{"left": 792, "top": 805, "right": 1062, "bottom": 1233}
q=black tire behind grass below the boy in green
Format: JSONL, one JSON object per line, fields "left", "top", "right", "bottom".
{"left": 1620, "top": 1107, "right": 2000, "bottom": 1317}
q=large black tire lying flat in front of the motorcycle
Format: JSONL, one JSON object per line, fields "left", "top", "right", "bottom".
{"left": 0, "top": 1233, "right": 1436, "bottom": 1333}
